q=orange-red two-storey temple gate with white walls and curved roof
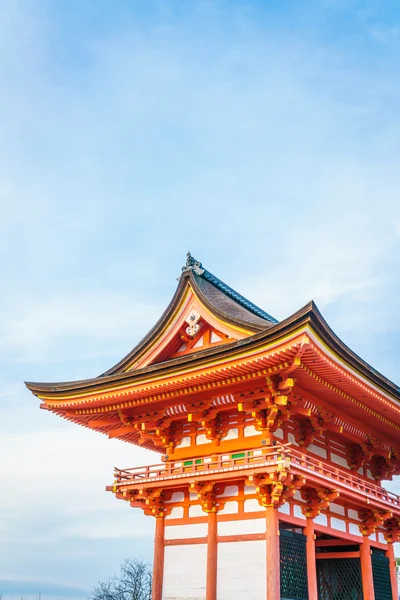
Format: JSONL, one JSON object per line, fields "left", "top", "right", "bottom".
{"left": 27, "top": 254, "right": 400, "bottom": 600}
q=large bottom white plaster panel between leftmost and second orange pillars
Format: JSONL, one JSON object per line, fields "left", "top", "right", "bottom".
{"left": 163, "top": 544, "right": 207, "bottom": 600}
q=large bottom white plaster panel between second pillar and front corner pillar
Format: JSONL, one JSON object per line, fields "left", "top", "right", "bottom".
{"left": 217, "top": 540, "right": 267, "bottom": 600}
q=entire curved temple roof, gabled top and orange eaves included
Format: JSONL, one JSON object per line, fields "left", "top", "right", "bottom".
{"left": 26, "top": 255, "right": 400, "bottom": 450}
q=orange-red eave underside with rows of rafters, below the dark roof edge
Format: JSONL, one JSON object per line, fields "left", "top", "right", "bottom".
{"left": 39, "top": 334, "right": 400, "bottom": 451}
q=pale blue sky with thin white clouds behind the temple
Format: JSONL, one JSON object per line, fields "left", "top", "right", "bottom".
{"left": 0, "top": 0, "right": 400, "bottom": 600}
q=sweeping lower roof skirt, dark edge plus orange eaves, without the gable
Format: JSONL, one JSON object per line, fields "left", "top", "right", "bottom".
{"left": 27, "top": 304, "right": 400, "bottom": 447}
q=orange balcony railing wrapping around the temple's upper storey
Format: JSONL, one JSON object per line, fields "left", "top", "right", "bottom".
{"left": 108, "top": 444, "right": 400, "bottom": 511}
